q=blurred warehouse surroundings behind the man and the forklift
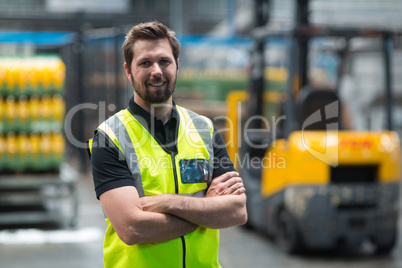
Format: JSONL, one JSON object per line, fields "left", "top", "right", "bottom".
{"left": 0, "top": 0, "right": 402, "bottom": 268}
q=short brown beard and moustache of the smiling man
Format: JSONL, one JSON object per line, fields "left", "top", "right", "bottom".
{"left": 131, "top": 74, "right": 177, "bottom": 104}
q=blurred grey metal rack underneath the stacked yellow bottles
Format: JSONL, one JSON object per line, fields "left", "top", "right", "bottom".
{"left": 0, "top": 167, "right": 78, "bottom": 227}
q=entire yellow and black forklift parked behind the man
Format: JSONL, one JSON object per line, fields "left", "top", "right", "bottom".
{"left": 226, "top": 0, "right": 400, "bottom": 254}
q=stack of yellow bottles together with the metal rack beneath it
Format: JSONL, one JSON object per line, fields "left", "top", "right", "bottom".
{"left": 0, "top": 55, "right": 78, "bottom": 229}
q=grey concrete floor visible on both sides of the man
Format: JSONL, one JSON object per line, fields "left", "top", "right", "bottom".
{"left": 0, "top": 172, "right": 402, "bottom": 268}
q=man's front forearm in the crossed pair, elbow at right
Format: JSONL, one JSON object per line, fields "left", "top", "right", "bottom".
{"left": 143, "top": 194, "right": 247, "bottom": 229}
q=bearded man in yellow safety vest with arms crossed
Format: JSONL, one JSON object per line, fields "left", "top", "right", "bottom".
{"left": 90, "top": 21, "right": 247, "bottom": 268}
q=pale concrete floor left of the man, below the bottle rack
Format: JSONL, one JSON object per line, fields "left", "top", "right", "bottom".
{"left": 0, "top": 172, "right": 106, "bottom": 268}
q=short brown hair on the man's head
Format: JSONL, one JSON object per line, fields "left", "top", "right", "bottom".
{"left": 122, "top": 21, "right": 180, "bottom": 71}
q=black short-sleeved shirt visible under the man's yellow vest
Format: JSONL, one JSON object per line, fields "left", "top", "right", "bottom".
{"left": 91, "top": 98, "right": 235, "bottom": 198}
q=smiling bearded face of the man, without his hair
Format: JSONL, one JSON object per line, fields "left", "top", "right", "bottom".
{"left": 125, "top": 39, "right": 178, "bottom": 107}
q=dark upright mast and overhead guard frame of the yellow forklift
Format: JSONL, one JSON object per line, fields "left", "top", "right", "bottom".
{"left": 248, "top": 0, "right": 394, "bottom": 133}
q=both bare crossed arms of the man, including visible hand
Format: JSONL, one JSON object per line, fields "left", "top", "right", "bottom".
{"left": 99, "top": 172, "right": 247, "bottom": 245}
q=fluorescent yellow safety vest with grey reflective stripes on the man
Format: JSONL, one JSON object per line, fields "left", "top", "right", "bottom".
{"left": 88, "top": 106, "right": 220, "bottom": 268}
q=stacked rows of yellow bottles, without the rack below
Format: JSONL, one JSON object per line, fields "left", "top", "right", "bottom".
{"left": 0, "top": 55, "right": 65, "bottom": 173}
